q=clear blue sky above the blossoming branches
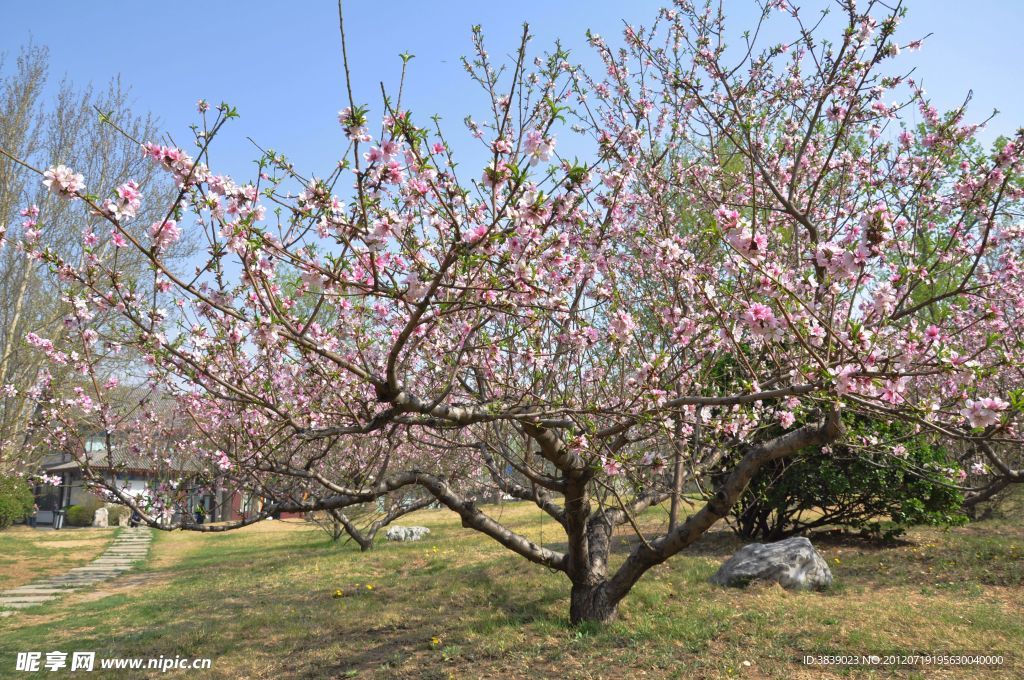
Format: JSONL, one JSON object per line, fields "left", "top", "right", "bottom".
{"left": 0, "top": 0, "right": 1024, "bottom": 178}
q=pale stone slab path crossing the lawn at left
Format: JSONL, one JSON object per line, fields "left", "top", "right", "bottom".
{"left": 0, "top": 527, "right": 153, "bottom": 617}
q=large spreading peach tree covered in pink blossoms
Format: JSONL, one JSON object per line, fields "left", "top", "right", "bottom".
{"left": 4, "top": 1, "right": 1024, "bottom": 622}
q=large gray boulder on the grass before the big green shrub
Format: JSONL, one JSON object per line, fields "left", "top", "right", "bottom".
{"left": 711, "top": 537, "right": 833, "bottom": 590}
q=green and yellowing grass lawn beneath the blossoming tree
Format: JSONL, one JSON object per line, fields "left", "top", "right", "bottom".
{"left": 0, "top": 505, "right": 1024, "bottom": 679}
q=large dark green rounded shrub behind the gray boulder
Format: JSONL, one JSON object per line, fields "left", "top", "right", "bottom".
{"left": 732, "top": 421, "right": 967, "bottom": 541}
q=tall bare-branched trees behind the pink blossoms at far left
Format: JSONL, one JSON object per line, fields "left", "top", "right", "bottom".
{"left": 0, "top": 44, "right": 187, "bottom": 472}
